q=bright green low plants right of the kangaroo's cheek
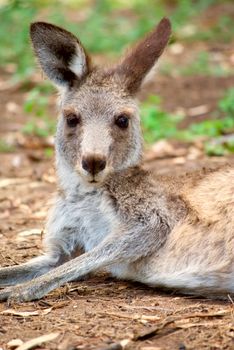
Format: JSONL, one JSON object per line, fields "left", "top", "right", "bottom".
{"left": 141, "top": 89, "right": 234, "bottom": 155}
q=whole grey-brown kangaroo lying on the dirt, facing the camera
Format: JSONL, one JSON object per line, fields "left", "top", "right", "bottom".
{"left": 0, "top": 18, "right": 234, "bottom": 302}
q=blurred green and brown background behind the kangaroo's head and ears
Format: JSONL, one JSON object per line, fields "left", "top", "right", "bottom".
{"left": 0, "top": 0, "right": 234, "bottom": 155}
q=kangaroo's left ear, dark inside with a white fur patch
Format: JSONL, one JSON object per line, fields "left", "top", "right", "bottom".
{"left": 30, "top": 22, "right": 90, "bottom": 87}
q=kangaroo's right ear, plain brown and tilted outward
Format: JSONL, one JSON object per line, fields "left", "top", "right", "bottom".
{"left": 116, "top": 18, "right": 171, "bottom": 94}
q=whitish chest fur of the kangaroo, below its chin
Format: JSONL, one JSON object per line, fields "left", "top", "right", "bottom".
{"left": 46, "top": 185, "right": 119, "bottom": 255}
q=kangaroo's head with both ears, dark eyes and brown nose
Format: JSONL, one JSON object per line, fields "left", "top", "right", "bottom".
{"left": 31, "top": 18, "right": 171, "bottom": 183}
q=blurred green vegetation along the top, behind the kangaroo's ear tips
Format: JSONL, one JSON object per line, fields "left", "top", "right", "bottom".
{"left": 0, "top": 0, "right": 229, "bottom": 80}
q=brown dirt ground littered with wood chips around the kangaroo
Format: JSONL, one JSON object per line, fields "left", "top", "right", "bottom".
{"left": 0, "top": 34, "right": 234, "bottom": 350}
